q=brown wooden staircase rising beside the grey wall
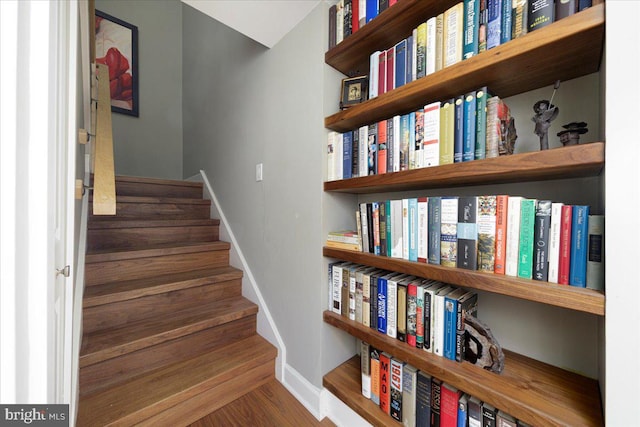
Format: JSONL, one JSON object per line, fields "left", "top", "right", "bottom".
{"left": 77, "top": 177, "right": 276, "bottom": 426}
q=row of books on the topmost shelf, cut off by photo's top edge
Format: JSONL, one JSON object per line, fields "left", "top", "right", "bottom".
{"left": 329, "top": 0, "right": 397, "bottom": 49}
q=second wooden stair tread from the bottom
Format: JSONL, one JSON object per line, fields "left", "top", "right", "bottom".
{"left": 80, "top": 297, "right": 258, "bottom": 367}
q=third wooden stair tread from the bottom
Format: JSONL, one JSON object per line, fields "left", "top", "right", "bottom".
{"left": 83, "top": 266, "right": 243, "bottom": 308}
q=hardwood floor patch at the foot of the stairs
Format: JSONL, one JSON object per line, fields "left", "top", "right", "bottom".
{"left": 190, "top": 379, "right": 335, "bottom": 427}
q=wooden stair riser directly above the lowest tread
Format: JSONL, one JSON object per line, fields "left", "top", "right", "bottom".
{"left": 80, "top": 315, "right": 256, "bottom": 396}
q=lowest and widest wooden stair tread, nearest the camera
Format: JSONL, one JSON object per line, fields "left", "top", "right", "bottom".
{"left": 78, "top": 335, "right": 276, "bottom": 426}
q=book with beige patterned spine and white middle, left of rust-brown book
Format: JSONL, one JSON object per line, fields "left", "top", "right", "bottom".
{"left": 478, "top": 196, "right": 497, "bottom": 273}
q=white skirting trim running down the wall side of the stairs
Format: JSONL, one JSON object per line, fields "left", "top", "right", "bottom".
{"left": 188, "top": 170, "right": 287, "bottom": 381}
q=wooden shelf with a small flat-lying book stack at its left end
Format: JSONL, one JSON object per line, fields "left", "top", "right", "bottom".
{"left": 322, "top": 247, "right": 605, "bottom": 316}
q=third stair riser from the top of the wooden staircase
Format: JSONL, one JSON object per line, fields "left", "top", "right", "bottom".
{"left": 87, "top": 225, "right": 220, "bottom": 251}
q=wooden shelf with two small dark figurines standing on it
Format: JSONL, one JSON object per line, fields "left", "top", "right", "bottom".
{"left": 324, "top": 142, "right": 605, "bottom": 194}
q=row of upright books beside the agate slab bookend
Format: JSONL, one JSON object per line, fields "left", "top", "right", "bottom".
{"left": 329, "top": 262, "right": 478, "bottom": 362}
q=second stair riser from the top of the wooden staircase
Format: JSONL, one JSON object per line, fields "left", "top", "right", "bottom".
{"left": 90, "top": 202, "right": 211, "bottom": 221}
